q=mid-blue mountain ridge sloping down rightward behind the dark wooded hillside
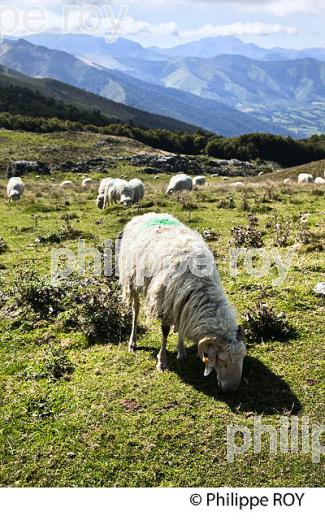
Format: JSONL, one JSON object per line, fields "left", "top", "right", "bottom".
{"left": 0, "top": 38, "right": 286, "bottom": 136}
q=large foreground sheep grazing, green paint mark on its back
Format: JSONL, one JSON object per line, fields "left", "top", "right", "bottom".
{"left": 118, "top": 213, "right": 246, "bottom": 392}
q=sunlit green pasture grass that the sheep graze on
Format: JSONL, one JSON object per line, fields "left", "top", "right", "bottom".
{"left": 0, "top": 132, "right": 325, "bottom": 487}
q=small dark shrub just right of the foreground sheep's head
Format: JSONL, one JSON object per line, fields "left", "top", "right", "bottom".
{"left": 244, "top": 303, "right": 295, "bottom": 342}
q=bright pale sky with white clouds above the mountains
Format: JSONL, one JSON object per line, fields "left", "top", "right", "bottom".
{"left": 0, "top": 0, "right": 325, "bottom": 48}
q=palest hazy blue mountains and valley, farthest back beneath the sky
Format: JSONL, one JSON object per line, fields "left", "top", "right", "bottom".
{"left": 20, "top": 34, "right": 325, "bottom": 136}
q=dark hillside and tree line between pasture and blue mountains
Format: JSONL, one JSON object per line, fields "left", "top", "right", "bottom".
{"left": 0, "top": 85, "right": 325, "bottom": 167}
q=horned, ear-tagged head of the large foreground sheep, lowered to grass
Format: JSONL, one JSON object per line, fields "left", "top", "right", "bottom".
{"left": 198, "top": 327, "right": 246, "bottom": 393}
